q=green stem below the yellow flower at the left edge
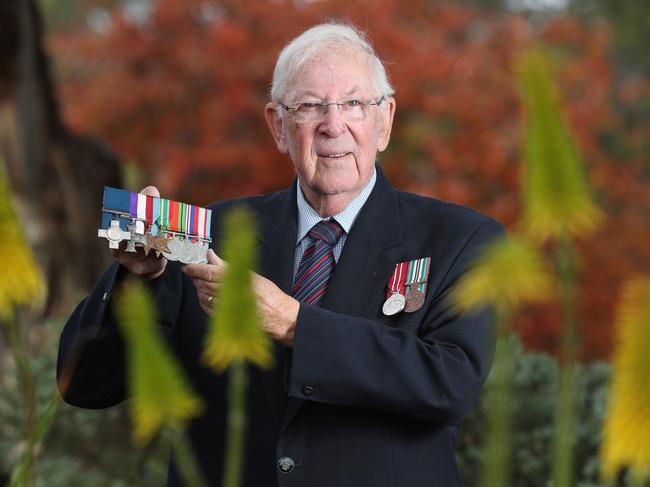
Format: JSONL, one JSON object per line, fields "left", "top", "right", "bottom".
{"left": 4, "top": 318, "right": 37, "bottom": 487}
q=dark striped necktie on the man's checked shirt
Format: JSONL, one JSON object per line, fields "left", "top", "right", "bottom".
{"left": 291, "top": 220, "right": 343, "bottom": 305}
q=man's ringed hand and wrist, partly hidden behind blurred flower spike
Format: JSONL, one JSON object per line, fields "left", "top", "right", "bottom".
{"left": 183, "top": 249, "right": 300, "bottom": 347}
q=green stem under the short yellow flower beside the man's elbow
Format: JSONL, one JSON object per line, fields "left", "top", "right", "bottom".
{"left": 482, "top": 313, "right": 517, "bottom": 487}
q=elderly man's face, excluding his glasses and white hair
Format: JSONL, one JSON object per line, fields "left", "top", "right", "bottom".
{"left": 266, "top": 49, "right": 395, "bottom": 209}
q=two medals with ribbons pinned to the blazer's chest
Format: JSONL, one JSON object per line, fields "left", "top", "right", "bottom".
{"left": 382, "top": 257, "right": 431, "bottom": 316}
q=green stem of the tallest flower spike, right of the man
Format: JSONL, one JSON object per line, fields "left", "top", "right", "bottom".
{"left": 553, "top": 237, "right": 579, "bottom": 487}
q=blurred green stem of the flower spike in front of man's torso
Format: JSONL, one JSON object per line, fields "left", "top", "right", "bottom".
{"left": 223, "top": 361, "right": 248, "bottom": 487}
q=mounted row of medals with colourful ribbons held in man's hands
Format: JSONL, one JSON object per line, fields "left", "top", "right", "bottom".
{"left": 97, "top": 186, "right": 212, "bottom": 264}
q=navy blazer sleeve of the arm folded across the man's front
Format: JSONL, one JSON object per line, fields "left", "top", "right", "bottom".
{"left": 288, "top": 221, "right": 504, "bottom": 424}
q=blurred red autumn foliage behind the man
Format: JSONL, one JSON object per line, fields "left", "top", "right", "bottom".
{"left": 49, "top": 0, "right": 650, "bottom": 359}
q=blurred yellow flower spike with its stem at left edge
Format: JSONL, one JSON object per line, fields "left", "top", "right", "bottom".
{"left": 0, "top": 164, "right": 58, "bottom": 487}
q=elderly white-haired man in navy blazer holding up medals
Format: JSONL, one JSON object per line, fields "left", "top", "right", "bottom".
{"left": 59, "top": 23, "right": 502, "bottom": 487}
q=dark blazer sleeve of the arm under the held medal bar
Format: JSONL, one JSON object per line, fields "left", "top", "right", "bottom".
{"left": 56, "top": 262, "right": 183, "bottom": 409}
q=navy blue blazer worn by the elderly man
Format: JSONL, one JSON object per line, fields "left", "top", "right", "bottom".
{"left": 57, "top": 169, "right": 503, "bottom": 487}
